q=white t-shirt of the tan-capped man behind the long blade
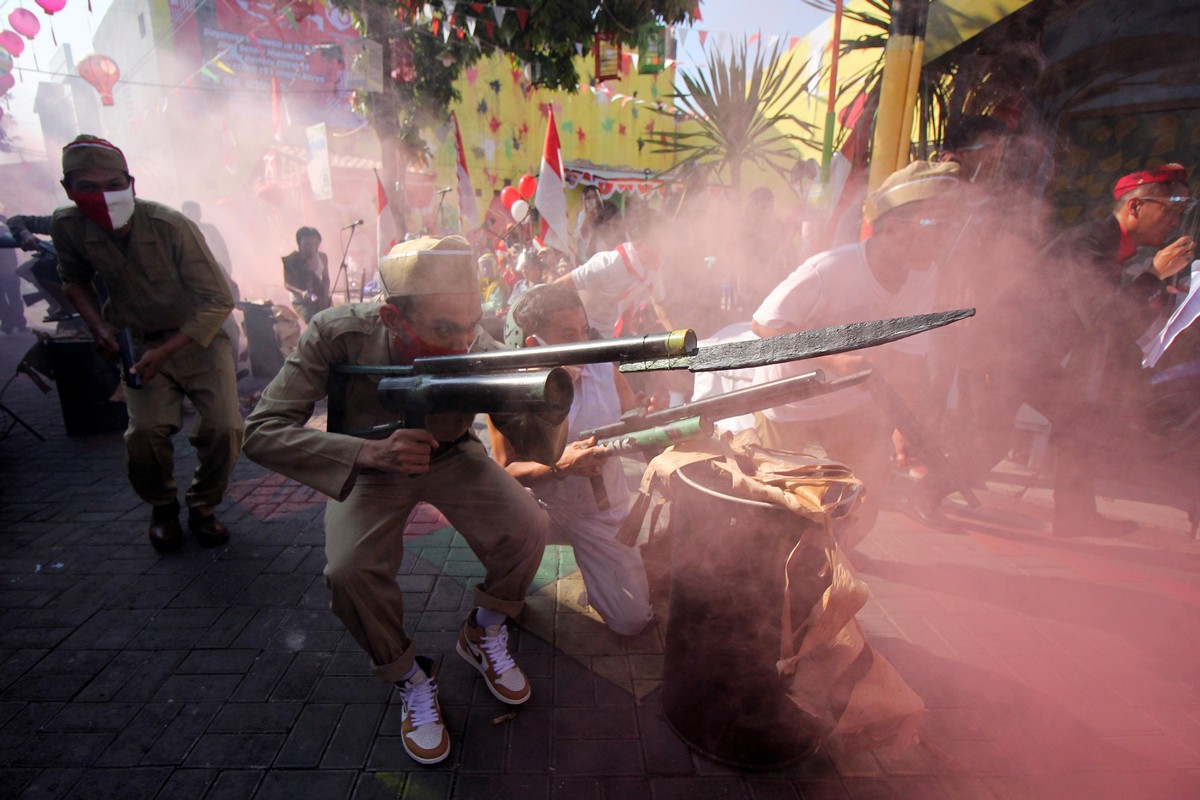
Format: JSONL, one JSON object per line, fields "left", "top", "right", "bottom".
{"left": 754, "top": 242, "right": 936, "bottom": 422}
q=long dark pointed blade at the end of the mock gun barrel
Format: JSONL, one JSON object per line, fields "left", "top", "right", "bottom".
{"left": 620, "top": 308, "right": 974, "bottom": 372}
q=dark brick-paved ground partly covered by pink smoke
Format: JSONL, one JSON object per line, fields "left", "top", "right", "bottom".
{"left": 0, "top": 328, "right": 1200, "bottom": 800}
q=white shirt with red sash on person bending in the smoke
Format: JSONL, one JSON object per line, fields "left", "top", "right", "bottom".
{"left": 571, "top": 242, "right": 666, "bottom": 336}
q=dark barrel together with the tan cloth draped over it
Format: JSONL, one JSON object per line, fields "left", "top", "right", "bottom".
{"left": 623, "top": 431, "right": 924, "bottom": 769}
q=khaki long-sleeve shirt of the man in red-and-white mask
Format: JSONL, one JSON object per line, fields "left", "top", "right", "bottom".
{"left": 50, "top": 200, "right": 233, "bottom": 347}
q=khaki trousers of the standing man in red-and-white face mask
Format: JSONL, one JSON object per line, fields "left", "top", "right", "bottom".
{"left": 125, "top": 332, "right": 242, "bottom": 513}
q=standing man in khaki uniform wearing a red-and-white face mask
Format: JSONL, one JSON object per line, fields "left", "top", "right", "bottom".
{"left": 50, "top": 134, "right": 242, "bottom": 551}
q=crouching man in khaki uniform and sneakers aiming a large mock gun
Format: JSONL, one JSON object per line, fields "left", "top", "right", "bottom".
{"left": 245, "top": 236, "right": 565, "bottom": 764}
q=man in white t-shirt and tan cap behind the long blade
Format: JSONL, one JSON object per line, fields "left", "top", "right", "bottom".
{"left": 751, "top": 162, "right": 960, "bottom": 548}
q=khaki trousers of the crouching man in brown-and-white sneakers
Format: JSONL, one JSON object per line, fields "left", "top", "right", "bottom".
{"left": 325, "top": 439, "right": 548, "bottom": 682}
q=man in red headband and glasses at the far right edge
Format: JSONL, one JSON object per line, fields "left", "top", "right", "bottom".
{"left": 1044, "top": 163, "right": 1195, "bottom": 536}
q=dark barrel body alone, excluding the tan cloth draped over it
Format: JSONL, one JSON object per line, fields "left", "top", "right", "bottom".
{"left": 662, "top": 463, "right": 820, "bottom": 769}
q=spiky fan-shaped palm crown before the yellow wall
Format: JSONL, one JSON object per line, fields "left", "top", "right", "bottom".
{"left": 652, "top": 41, "right": 820, "bottom": 190}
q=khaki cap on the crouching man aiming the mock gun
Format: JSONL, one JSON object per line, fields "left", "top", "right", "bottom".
{"left": 379, "top": 236, "right": 479, "bottom": 297}
